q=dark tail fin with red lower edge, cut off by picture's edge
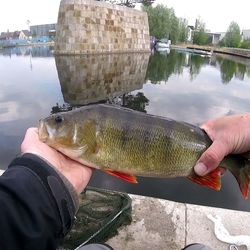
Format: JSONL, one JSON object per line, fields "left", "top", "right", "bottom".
{"left": 227, "top": 159, "right": 250, "bottom": 200}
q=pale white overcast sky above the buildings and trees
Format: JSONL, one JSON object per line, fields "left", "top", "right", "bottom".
{"left": 0, "top": 0, "right": 250, "bottom": 32}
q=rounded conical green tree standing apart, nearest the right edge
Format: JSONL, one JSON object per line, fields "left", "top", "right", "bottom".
{"left": 223, "top": 22, "right": 241, "bottom": 48}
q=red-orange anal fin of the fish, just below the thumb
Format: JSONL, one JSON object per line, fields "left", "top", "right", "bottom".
{"left": 187, "top": 167, "right": 223, "bottom": 190}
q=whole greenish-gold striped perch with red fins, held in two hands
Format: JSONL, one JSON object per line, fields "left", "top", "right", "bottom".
{"left": 38, "top": 105, "right": 250, "bottom": 199}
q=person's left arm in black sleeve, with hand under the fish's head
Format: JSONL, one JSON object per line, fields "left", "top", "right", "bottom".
{"left": 0, "top": 128, "right": 92, "bottom": 250}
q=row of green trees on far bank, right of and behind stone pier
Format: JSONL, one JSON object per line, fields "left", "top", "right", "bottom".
{"left": 97, "top": 0, "right": 250, "bottom": 49}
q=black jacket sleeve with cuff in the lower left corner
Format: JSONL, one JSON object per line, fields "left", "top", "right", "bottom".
{"left": 0, "top": 154, "right": 76, "bottom": 250}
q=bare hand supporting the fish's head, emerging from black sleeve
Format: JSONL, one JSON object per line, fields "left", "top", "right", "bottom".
{"left": 21, "top": 128, "right": 92, "bottom": 194}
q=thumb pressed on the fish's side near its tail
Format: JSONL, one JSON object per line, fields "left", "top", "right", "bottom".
{"left": 194, "top": 140, "right": 228, "bottom": 176}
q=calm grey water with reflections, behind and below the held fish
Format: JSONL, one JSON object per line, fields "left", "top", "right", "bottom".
{"left": 0, "top": 47, "right": 250, "bottom": 211}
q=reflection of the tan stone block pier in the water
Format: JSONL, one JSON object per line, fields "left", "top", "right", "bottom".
{"left": 55, "top": 53, "right": 149, "bottom": 106}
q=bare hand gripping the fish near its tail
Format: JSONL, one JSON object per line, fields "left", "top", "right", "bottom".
{"left": 194, "top": 113, "right": 250, "bottom": 176}
